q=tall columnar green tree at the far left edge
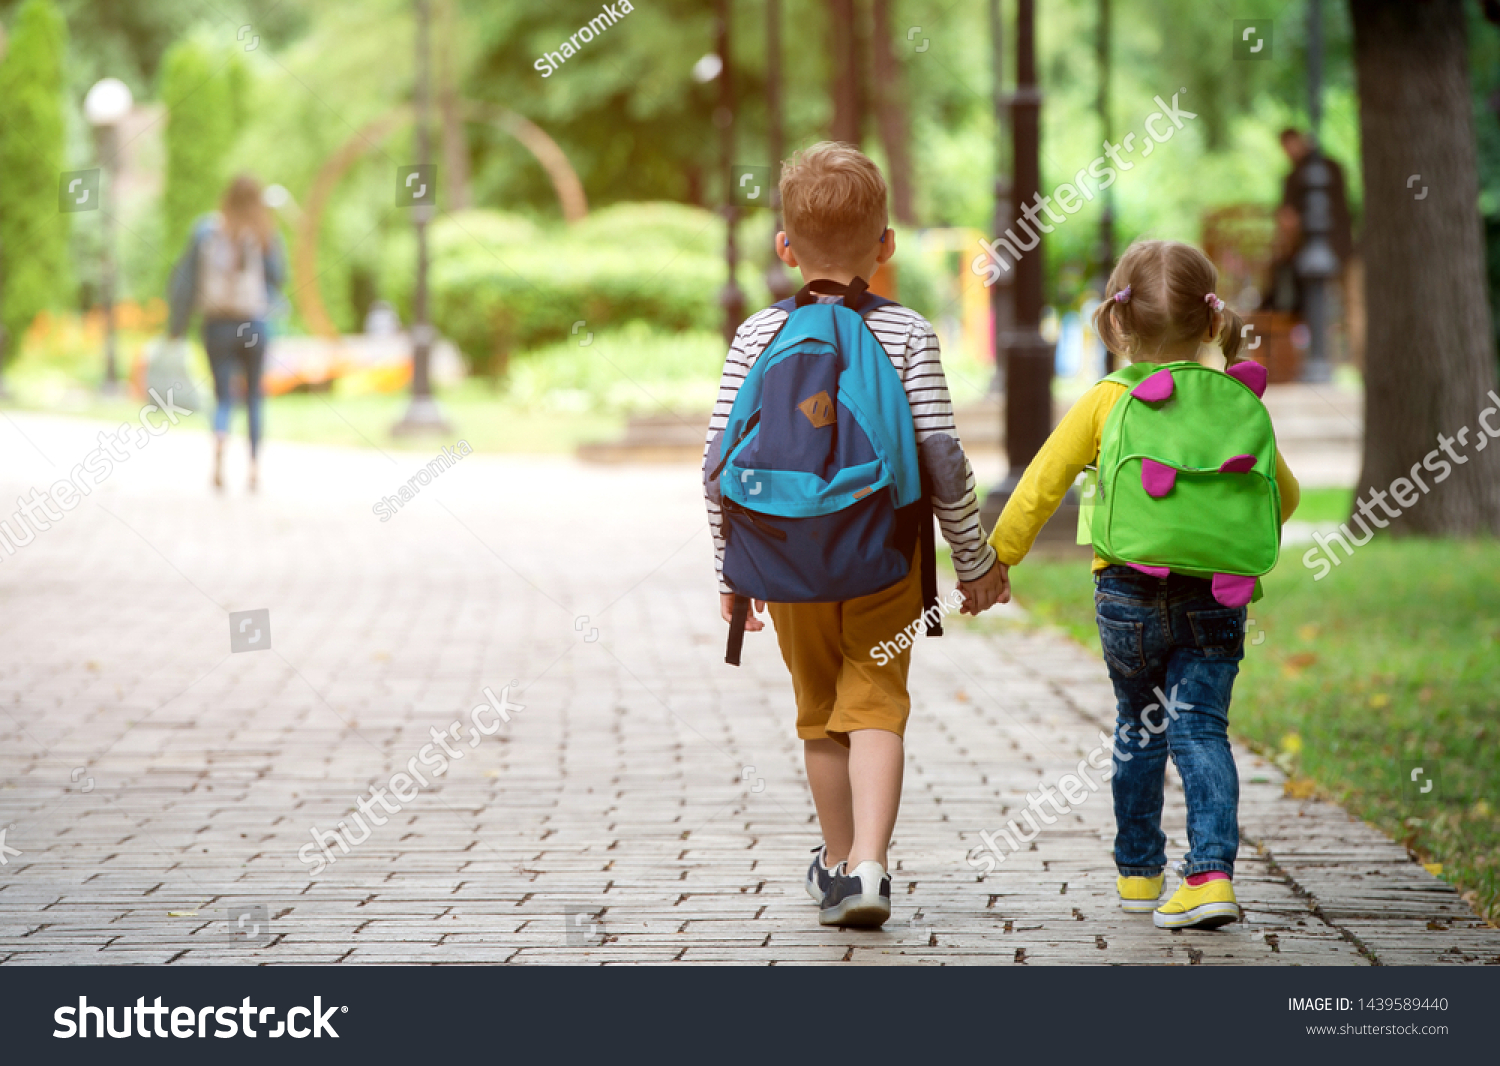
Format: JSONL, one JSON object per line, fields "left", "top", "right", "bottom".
{"left": 0, "top": 0, "right": 69, "bottom": 358}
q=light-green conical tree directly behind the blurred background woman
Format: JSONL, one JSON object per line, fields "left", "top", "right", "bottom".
{"left": 161, "top": 39, "right": 248, "bottom": 271}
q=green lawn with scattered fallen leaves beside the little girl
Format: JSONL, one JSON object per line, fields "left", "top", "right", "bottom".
{"left": 984, "top": 542, "right": 1500, "bottom": 922}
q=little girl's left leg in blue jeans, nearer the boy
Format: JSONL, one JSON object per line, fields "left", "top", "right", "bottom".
{"left": 1095, "top": 567, "right": 1167, "bottom": 877}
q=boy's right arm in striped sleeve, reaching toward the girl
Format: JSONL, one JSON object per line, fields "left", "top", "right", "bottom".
{"left": 894, "top": 312, "right": 995, "bottom": 582}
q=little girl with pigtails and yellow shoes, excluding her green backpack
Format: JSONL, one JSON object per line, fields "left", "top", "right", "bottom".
{"left": 990, "top": 240, "right": 1299, "bottom": 928}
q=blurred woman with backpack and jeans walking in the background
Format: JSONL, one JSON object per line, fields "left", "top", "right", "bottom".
{"left": 167, "top": 174, "right": 287, "bottom": 492}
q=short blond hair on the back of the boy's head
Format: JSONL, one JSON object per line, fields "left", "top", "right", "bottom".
{"left": 780, "top": 141, "right": 890, "bottom": 268}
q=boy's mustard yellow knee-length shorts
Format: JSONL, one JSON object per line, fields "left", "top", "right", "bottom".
{"left": 768, "top": 565, "right": 923, "bottom": 747}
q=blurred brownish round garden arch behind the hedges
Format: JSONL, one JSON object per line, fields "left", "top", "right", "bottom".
{"left": 291, "top": 100, "right": 588, "bottom": 337}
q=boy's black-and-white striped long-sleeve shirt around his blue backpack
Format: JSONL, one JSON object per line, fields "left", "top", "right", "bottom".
{"left": 704, "top": 297, "right": 995, "bottom": 592}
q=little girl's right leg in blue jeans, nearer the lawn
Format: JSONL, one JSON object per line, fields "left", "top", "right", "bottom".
{"left": 1164, "top": 597, "right": 1245, "bottom": 877}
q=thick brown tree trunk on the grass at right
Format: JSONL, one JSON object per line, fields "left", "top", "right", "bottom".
{"left": 1350, "top": 0, "right": 1500, "bottom": 535}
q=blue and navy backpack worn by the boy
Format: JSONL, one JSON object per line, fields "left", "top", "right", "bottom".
{"left": 705, "top": 277, "right": 942, "bottom": 666}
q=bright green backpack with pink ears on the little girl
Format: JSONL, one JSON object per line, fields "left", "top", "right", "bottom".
{"left": 1079, "top": 361, "right": 1281, "bottom": 607}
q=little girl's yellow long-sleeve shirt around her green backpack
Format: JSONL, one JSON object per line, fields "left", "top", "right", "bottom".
{"left": 990, "top": 381, "right": 1302, "bottom": 570}
